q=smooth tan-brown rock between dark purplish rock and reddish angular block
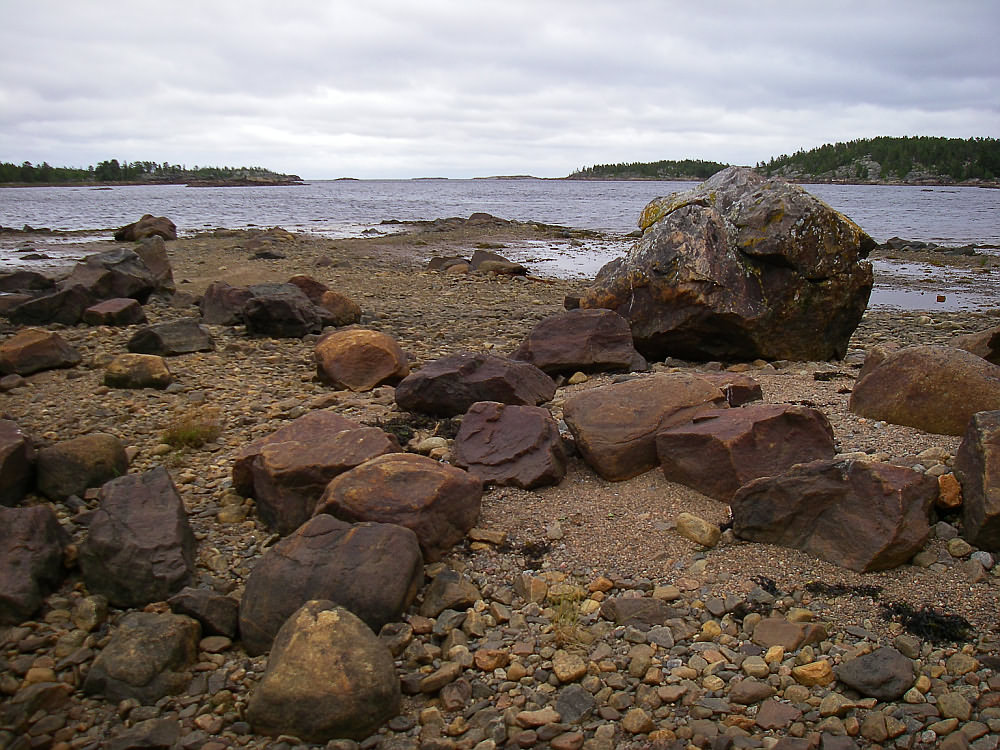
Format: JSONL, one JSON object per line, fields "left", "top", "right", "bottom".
{"left": 563, "top": 373, "right": 726, "bottom": 481}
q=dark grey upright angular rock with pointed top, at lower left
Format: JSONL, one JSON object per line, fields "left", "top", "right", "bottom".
{"left": 80, "top": 466, "right": 196, "bottom": 607}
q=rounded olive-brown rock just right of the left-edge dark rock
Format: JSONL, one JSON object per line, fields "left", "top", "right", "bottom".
{"left": 36, "top": 432, "right": 128, "bottom": 500}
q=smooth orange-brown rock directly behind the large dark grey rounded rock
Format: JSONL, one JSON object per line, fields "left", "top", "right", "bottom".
{"left": 316, "top": 453, "right": 483, "bottom": 562}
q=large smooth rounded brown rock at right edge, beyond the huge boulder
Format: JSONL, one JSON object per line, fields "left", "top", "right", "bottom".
{"left": 848, "top": 346, "right": 1000, "bottom": 435}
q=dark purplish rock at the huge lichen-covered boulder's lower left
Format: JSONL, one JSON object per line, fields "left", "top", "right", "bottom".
{"left": 510, "top": 309, "right": 647, "bottom": 375}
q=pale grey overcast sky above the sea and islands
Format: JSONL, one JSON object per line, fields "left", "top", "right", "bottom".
{"left": 0, "top": 0, "right": 1000, "bottom": 179}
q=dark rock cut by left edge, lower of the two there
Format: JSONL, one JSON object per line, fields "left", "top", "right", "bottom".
{"left": 0, "top": 505, "right": 70, "bottom": 625}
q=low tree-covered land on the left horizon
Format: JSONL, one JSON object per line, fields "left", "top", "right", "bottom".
{"left": 0, "top": 159, "right": 302, "bottom": 187}
